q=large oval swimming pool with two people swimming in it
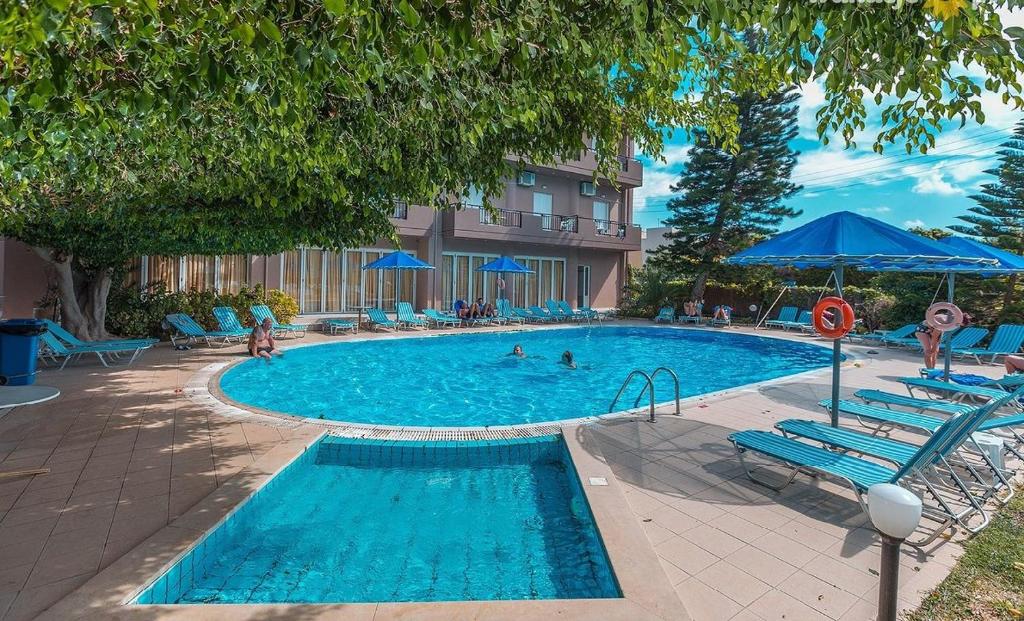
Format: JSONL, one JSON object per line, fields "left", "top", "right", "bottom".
{"left": 220, "top": 326, "right": 831, "bottom": 426}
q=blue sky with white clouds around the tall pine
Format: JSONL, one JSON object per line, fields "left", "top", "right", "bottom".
{"left": 633, "top": 10, "right": 1024, "bottom": 235}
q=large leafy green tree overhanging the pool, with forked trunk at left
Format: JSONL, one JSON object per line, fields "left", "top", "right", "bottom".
{"left": 0, "top": 0, "right": 1024, "bottom": 337}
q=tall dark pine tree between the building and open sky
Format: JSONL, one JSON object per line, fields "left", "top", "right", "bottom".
{"left": 653, "top": 65, "right": 801, "bottom": 299}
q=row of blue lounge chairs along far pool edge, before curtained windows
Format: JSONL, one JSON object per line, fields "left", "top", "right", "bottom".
{"left": 367, "top": 299, "right": 601, "bottom": 330}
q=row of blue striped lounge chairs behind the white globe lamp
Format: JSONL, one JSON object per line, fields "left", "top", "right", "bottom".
{"left": 729, "top": 376, "right": 1024, "bottom": 545}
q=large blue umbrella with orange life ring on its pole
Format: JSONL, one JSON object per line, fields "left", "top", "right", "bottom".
{"left": 726, "top": 211, "right": 994, "bottom": 426}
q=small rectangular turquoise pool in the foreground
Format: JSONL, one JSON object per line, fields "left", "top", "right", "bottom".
{"left": 135, "top": 437, "right": 621, "bottom": 604}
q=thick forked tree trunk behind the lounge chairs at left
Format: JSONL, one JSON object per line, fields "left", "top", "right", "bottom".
{"left": 34, "top": 248, "right": 111, "bottom": 340}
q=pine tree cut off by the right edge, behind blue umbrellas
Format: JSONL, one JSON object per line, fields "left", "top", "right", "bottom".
{"left": 950, "top": 120, "right": 1024, "bottom": 309}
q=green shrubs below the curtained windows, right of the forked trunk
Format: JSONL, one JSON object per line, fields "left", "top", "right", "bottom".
{"left": 106, "top": 282, "right": 299, "bottom": 338}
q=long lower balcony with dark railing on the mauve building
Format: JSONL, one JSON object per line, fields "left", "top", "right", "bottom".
{"left": 443, "top": 205, "right": 640, "bottom": 251}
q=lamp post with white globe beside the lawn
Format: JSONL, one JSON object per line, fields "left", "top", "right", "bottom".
{"left": 867, "top": 483, "right": 921, "bottom": 621}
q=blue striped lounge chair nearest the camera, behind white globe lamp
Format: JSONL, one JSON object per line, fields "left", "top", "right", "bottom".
{"left": 729, "top": 390, "right": 1024, "bottom": 546}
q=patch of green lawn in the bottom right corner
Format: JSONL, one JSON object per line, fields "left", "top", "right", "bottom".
{"left": 907, "top": 490, "right": 1024, "bottom": 621}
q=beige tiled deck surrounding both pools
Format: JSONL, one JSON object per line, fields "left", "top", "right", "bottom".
{"left": 0, "top": 324, "right": 998, "bottom": 621}
